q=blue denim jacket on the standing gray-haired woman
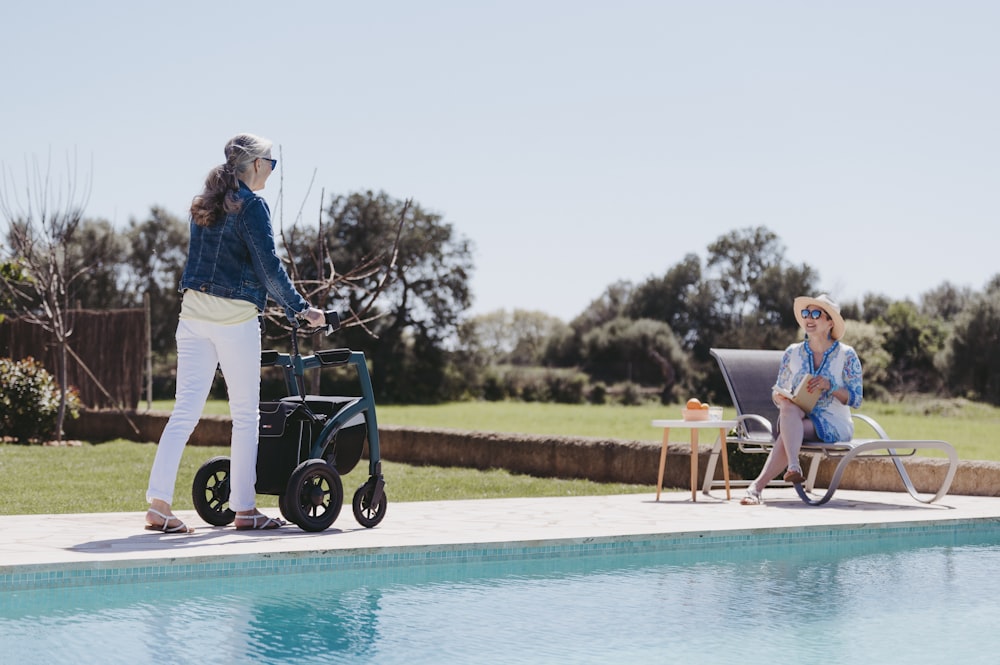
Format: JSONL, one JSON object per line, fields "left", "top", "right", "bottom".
{"left": 180, "top": 182, "right": 309, "bottom": 320}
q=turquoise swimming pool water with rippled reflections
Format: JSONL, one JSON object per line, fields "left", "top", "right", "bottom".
{"left": 0, "top": 523, "right": 1000, "bottom": 664}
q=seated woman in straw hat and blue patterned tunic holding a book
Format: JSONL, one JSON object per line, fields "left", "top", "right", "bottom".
{"left": 740, "top": 294, "right": 862, "bottom": 506}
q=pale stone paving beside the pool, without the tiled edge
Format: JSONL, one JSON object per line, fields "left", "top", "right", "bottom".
{"left": 0, "top": 488, "right": 1000, "bottom": 587}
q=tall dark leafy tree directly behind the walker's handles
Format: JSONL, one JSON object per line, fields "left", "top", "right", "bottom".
{"left": 285, "top": 191, "right": 472, "bottom": 402}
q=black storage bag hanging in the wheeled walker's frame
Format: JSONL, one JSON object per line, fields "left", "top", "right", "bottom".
{"left": 257, "top": 401, "right": 316, "bottom": 494}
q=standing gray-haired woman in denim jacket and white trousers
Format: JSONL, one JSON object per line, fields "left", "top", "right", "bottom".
{"left": 146, "top": 134, "right": 324, "bottom": 533}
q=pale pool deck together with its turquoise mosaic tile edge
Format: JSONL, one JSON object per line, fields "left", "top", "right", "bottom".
{"left": 0, "top": 490, "right": 1000, "bottom": 591}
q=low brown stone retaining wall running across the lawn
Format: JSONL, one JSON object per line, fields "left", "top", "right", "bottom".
{"left": 66, "top": 411, "right": 1000, "bottom": 496}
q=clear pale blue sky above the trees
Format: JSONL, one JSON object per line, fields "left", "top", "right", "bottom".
{"left": 0, "top": 0, "right": 1000, "bottom": 320}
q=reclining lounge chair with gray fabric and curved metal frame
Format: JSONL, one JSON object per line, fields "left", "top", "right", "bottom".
{"left": 705, "top": 349, "right": 958, "bottom": 506}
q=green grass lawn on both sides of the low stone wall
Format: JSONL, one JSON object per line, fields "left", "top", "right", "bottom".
{"left": 0, "top": 400, "right": 1000, "bottom": 515}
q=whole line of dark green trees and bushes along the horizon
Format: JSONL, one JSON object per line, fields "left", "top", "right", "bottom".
{"left": 0, "top": 184, "right": 1000, "bottom": 404}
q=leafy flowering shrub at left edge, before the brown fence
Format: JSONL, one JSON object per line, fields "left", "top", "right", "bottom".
{"left": 0, "top": 358, "right": 80, "bottom": 444}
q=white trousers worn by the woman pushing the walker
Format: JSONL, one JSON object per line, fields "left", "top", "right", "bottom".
{"left": 146, "top": 319, "right": 260, "bottom": 511}
